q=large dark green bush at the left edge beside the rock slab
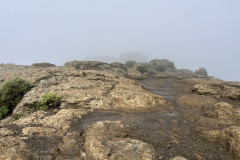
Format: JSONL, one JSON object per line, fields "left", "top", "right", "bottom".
{"left": 0, "top": 77, "right": 33, "bottom": 111}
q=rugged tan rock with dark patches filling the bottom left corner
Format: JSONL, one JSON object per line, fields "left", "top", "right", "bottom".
{"left": 0, "top": 109, "right": 92, "bottom": 160}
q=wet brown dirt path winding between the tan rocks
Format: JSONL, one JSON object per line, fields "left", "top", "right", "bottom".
{"left": 71, "top": 80, "right": 234, "bottom": 160}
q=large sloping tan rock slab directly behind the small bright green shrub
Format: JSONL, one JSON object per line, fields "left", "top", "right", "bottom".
{"left": 13, "top": 67, "right": 165, "bottom": 115}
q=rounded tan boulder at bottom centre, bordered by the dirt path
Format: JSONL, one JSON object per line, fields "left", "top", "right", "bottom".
{"left": 85, "top": 121, "right": 155, "bottom": 160}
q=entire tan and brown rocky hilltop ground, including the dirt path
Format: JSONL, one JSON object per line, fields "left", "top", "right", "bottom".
{"left": 0, "top": 61, "right": 240, "bottom": 160}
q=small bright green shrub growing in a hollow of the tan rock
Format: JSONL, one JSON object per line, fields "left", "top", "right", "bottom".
{"left": 37, "top": 93, "right": 62, "bottom": 110}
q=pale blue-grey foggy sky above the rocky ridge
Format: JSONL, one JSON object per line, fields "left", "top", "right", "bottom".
{"left": 0, "top": 0, "right": 240, "bottom": 81}
